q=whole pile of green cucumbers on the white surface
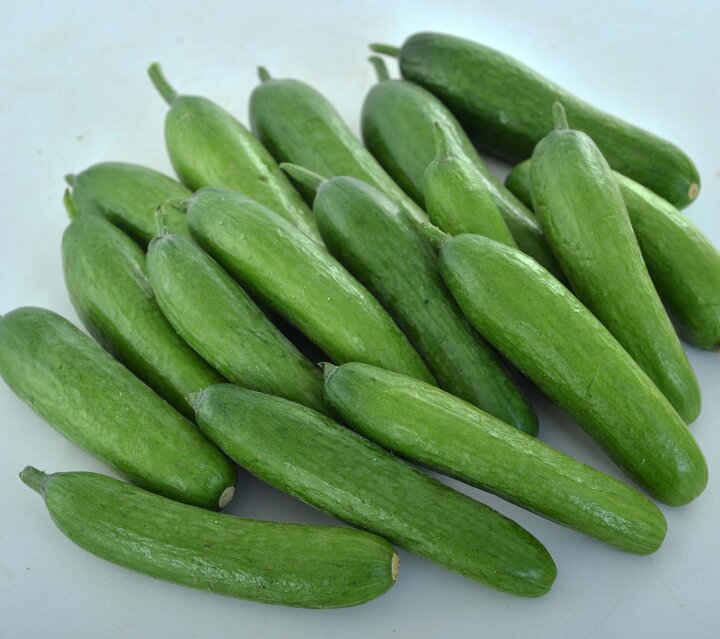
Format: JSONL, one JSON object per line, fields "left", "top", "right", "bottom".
{"left": 0, "top": 33, "right": 720, "bottom": 608}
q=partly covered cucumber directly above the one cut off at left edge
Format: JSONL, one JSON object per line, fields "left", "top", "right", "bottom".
{"left": 62, "top": 216, "right": 224, "bottom": 419}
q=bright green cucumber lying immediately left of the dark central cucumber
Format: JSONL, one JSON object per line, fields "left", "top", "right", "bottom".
{"left": 187, "top": 189, "right": 433, "bottom": 381}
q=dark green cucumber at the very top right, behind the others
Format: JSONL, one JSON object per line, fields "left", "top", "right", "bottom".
{"left": 380, "top": 33, "right": 700, "bottom": 207}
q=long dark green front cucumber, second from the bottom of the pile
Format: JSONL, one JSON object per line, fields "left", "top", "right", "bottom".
{"left": 195, "top": 384, "right": 556, "bottom": 597}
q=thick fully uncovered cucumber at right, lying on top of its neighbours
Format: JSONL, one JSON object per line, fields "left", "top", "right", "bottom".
{"left": 440, "top": 235, "right": 708, "bottom": 506}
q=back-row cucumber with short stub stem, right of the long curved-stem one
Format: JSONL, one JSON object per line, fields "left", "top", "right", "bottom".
{"left": 250, "top": 67, "right": 427, "bottom": 222}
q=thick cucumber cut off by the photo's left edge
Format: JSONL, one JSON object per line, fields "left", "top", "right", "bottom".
{"left": 0, "top": 308, "right": 236, "bottom": 508}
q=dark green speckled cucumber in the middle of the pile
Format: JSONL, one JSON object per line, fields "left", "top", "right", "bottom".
{"left": 314, "top": 177, "right": 538, "bottom": 435}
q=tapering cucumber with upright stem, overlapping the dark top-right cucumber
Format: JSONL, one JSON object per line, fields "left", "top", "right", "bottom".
{"left": 531, "top": 103, "right": 701, "bottom": 423}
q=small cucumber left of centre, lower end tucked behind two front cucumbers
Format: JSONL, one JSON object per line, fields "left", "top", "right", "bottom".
{"left": 148, "top": 235, "right": 323, "bottom": 416}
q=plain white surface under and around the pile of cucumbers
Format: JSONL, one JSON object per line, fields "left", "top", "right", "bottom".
{"left": 0, "top": 0, "right": 720, "bottom": 639}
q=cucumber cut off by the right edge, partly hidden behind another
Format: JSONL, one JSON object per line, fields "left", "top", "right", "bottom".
{"left": 507, "top": 160, "right": 720, "bottom": 351}
